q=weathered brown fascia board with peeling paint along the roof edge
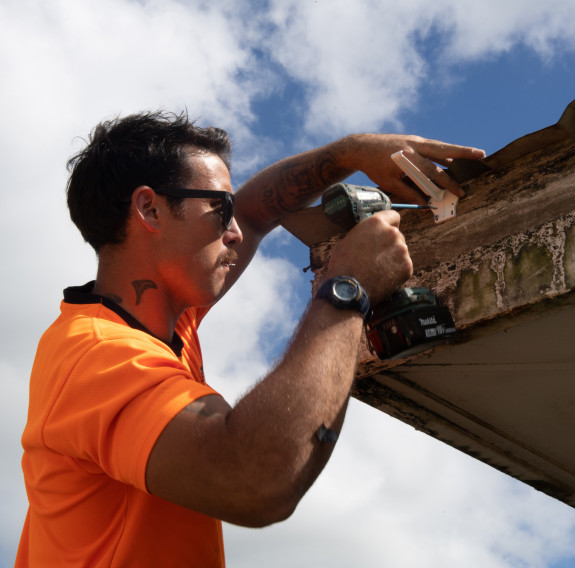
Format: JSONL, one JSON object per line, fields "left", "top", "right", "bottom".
{"left": 304, "top": 137, "right": 575, "bottom": 376}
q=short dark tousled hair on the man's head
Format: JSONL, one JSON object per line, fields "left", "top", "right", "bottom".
{"left": 67, "top": 111, "right": 231, "bottom": 252}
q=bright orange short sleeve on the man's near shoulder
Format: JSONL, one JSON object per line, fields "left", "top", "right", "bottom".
{"left": 43, "top": 334, "right": 217, "bottom": 491}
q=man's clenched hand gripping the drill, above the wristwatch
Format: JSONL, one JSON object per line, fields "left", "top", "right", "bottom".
{"left": 326, "top": 211, "right": 413, "bottom": 305}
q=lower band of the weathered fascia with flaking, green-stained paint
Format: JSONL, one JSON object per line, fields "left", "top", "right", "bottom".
{"left": 408, "top": 213, "right": 575, "bottom": 325}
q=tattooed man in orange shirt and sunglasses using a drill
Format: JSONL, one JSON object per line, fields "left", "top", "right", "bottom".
{"left": 16, "top": 108, "right": 483, "bottom": 568}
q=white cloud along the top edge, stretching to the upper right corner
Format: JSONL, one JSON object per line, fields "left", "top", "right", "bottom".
{"left": 260, "top": 0, "right": 575, "bottom": 140}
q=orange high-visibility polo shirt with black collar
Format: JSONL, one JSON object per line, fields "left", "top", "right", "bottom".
{"left": 16, "top": 283, "right": 224, "bottom": 568}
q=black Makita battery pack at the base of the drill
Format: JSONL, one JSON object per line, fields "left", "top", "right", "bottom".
{"left": 366, "top": 288, "right": 456, "bottom": 359}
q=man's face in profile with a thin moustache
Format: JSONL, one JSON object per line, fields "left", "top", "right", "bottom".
{"left": 156, "top": 154, "right": 243, "bottom": 309}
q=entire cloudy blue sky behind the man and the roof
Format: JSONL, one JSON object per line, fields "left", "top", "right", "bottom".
{"left": 0, "top": 0, "right": 575, "bottom": 568}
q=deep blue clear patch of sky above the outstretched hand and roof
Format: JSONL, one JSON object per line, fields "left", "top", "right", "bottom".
{"left": 405, "top": 46, "right": 575, "bottom": 154}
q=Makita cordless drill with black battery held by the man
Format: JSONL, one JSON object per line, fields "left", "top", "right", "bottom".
{"left": 321, "top": 183, "right": 456, "bottom": 359}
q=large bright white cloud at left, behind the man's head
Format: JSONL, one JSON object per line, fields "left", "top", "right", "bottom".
{"left": 0, "top": 0, "right": 270, "bottom": 364}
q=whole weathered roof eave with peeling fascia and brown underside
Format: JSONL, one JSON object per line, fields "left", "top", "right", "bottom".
{"left": 287, "top": 104, "right": 575, "bottom": 506}
